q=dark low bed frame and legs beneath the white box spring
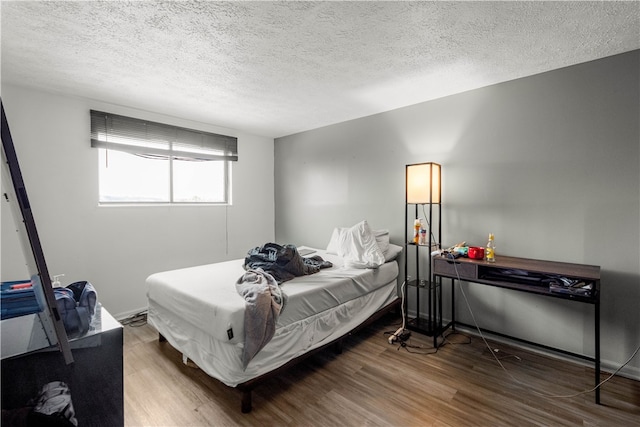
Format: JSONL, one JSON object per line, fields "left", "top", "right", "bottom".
{"left": 158, "top": 298, "right": 400, "bottom": 414}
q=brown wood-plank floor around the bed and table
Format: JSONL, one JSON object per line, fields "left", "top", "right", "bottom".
{"left": 124, "top": 316, "right": 640, "bottom": 426}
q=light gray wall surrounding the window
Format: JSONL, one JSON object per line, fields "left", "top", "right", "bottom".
{"left": 0, "top": 85, "right": 275, "bottom": 318}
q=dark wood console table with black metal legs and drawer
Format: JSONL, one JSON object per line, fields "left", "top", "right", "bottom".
{"left": 433, "top": 256, "right": 600, "bottom": 404}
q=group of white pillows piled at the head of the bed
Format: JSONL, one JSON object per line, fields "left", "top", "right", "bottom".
{"left": 327, "top": 220, "right": 402, "bottom": 268}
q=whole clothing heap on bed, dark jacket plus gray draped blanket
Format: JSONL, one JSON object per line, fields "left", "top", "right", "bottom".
{"left": 236, "top": 243, "right": 333, "bottom": 369}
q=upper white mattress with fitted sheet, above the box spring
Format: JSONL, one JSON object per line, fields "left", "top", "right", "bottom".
{"left": 147, "top": 250, "right": 398, "bottom": 342}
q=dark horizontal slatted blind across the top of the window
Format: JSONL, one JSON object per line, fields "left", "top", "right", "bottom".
{"left": 91, "top": 110, "right": 238, "bottom": 161}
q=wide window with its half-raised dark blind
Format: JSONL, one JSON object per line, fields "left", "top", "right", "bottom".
{"left": 91, "top": 110, "right": 238, "bottom": 204}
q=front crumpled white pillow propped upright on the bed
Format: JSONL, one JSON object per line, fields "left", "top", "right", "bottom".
{"left": 338, "top": 221, "right": 385, "bottom": 268}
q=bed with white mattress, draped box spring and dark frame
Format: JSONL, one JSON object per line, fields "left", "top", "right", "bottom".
{"left": 146, "top": 222, "right": 401, "bottom": 412}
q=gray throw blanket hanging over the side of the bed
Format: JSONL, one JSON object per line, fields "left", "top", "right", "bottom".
{"left": 236, "top": 268, "right": 285, "bottom": 369}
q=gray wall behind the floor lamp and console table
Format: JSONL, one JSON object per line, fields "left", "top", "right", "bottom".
{"left": 275, "top": 51, "right": 640, "bottom": 378}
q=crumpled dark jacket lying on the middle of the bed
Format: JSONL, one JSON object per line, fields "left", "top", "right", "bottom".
{"left": 244, "top": 243, "right": 333, "bottom": 283}
